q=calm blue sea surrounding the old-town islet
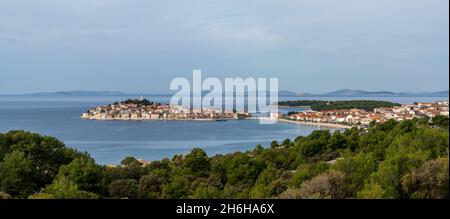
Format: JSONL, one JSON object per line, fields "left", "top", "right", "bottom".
{"left": 0, "top": 95, "right": 448, "bottom": 165}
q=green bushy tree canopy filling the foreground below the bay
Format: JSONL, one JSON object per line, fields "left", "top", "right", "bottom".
{"left": 0, "top": 117, "right": 449, "bottom": 199}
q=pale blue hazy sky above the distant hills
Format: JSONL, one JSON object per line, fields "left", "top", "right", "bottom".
{"left": 0, "top": 0, "right": 449, "bottom": 94}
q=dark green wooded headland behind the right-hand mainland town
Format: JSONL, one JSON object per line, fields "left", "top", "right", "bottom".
{"left": 278, "top": 100, "right": 400, "bottom": 111}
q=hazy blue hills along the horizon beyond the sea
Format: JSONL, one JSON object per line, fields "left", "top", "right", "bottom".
{"left": 5, "top": 89, "right": 449, "bottom": 97}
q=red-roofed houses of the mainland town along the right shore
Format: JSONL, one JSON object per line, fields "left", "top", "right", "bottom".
{"left": 281, "top": 101, "right": 449, "bottom": 126}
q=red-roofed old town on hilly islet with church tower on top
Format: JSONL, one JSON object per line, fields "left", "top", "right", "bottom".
{"left": 81, "top": 97, "right": 251, "bottom": 121}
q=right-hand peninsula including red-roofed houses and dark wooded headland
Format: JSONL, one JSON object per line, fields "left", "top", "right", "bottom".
{"left": 278, "top": 100, "right": 449, "bottom": 128}
